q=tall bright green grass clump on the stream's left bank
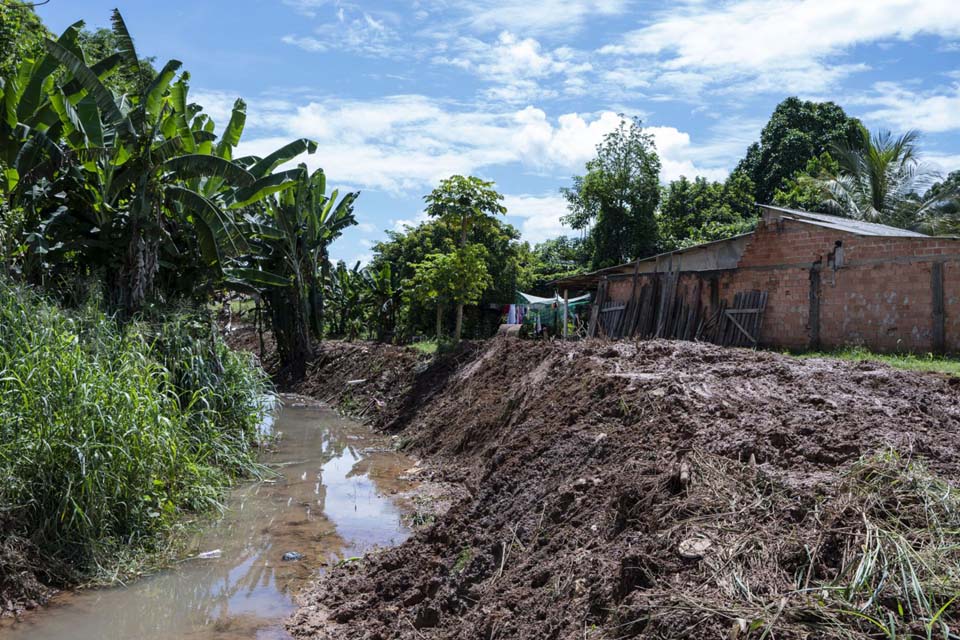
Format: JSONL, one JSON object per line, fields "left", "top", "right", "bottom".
{"left": 0, "top": 283, "right": 268, "bottom": 575}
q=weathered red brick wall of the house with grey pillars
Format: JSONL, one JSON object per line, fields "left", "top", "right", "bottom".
{"left": 609, "top": 220, "right": 960, "bottom": 352}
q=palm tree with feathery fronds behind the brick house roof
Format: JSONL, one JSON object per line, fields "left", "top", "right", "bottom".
{"left": 820, "top": 129, "right": 943, "bottom": 230}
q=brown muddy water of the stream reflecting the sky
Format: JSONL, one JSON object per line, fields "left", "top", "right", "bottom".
{"left": 0, "top": 400, "right": 413, "bottom": 640}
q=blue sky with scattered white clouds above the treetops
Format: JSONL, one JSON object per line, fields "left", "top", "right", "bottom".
{"left": 37, "top": 0, "right": 960, "bottom": 262}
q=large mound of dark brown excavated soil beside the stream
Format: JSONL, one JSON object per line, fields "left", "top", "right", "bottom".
{"left": 290, "top": 340, "right": 960, "bottom": 640}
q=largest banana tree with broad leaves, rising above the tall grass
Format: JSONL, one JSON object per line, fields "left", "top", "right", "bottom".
{"left": 37, "top": 11, "right": 256, "bottom": 314}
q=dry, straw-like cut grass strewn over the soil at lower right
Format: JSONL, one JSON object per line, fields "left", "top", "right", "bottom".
{"left": 611, "top": 452, "right": 960, "bottom": 640}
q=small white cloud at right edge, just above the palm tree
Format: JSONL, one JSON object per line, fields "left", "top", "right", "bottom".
{"left": 857, "top": 82, "right": 960, "bottom": 133}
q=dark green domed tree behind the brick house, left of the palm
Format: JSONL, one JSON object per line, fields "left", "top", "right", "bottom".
{"left": 737, "top": 97, "right": 862, "bottom": 204}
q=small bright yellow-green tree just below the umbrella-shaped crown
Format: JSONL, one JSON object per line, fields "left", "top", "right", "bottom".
{"left": 405, "top": 244, "right": 492, "bottom": 342}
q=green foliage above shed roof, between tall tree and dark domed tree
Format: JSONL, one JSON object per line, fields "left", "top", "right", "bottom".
{"left": 657, "top": 172, "right": 756, "bottom": 250}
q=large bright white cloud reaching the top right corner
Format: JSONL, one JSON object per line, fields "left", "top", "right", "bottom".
{"left": 601, "top": 0, "right": 960, "bottom": 93}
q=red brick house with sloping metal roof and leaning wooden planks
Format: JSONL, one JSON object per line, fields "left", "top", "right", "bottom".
{"left": 554, "top": 205, "right": 960, "bottom": 352}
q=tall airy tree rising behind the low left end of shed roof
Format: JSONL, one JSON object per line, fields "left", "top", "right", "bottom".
{"left": 562, "top": 119, "right": 660, "bottom": 269}
